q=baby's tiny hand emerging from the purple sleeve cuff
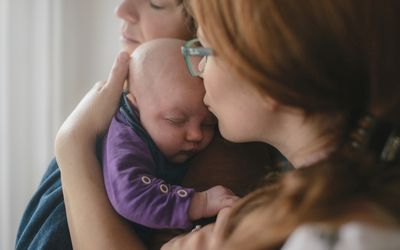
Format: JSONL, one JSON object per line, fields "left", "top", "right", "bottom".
{"left": 189, "top": 186, "right": 239, "bottom": 220}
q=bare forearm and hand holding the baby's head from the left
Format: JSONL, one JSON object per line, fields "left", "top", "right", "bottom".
{"left": 56, "top": 52, "right": 144, "bottom": 250}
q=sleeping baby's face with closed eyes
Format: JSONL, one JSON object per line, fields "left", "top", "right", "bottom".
{"left": 138, "top": 78, "right": 217, "bottom": 163}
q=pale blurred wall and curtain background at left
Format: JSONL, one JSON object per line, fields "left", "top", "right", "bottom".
{"left": 0, "top": 0, "right": 119, "bottom": 249}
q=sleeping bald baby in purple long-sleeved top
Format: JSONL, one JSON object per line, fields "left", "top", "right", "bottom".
{"left": 103, "top": 39, "right": 238, "bottom": 239}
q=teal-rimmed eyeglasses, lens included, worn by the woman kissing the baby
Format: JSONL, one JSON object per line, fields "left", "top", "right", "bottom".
{"left": 182, "top": 38, "right": 214, "bottom": 76}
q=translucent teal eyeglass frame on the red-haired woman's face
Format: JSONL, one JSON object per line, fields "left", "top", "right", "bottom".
{"left": 181, "top": 38, "right": 214, "bottom": 76}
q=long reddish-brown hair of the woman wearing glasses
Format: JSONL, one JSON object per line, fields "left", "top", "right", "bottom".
{"left": 190, "top": 0, "right": 400, "bottom": 249}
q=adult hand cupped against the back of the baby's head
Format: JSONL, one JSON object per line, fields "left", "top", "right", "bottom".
{"left": 56, "top": 52, "right": 130, "bottom": 156}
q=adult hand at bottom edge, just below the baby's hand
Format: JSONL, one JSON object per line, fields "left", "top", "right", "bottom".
{"left": 161, "top": 207, "right": 231, "bottom": 250}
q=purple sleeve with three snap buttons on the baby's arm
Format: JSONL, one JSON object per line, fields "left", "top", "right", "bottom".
{"left": 103, "top": 114, "right": 194, "bottom": 229}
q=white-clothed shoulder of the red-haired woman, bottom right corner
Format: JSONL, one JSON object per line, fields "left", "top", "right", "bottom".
{"left": 282, "top": 222, "right": 400, "bottom": 250}
